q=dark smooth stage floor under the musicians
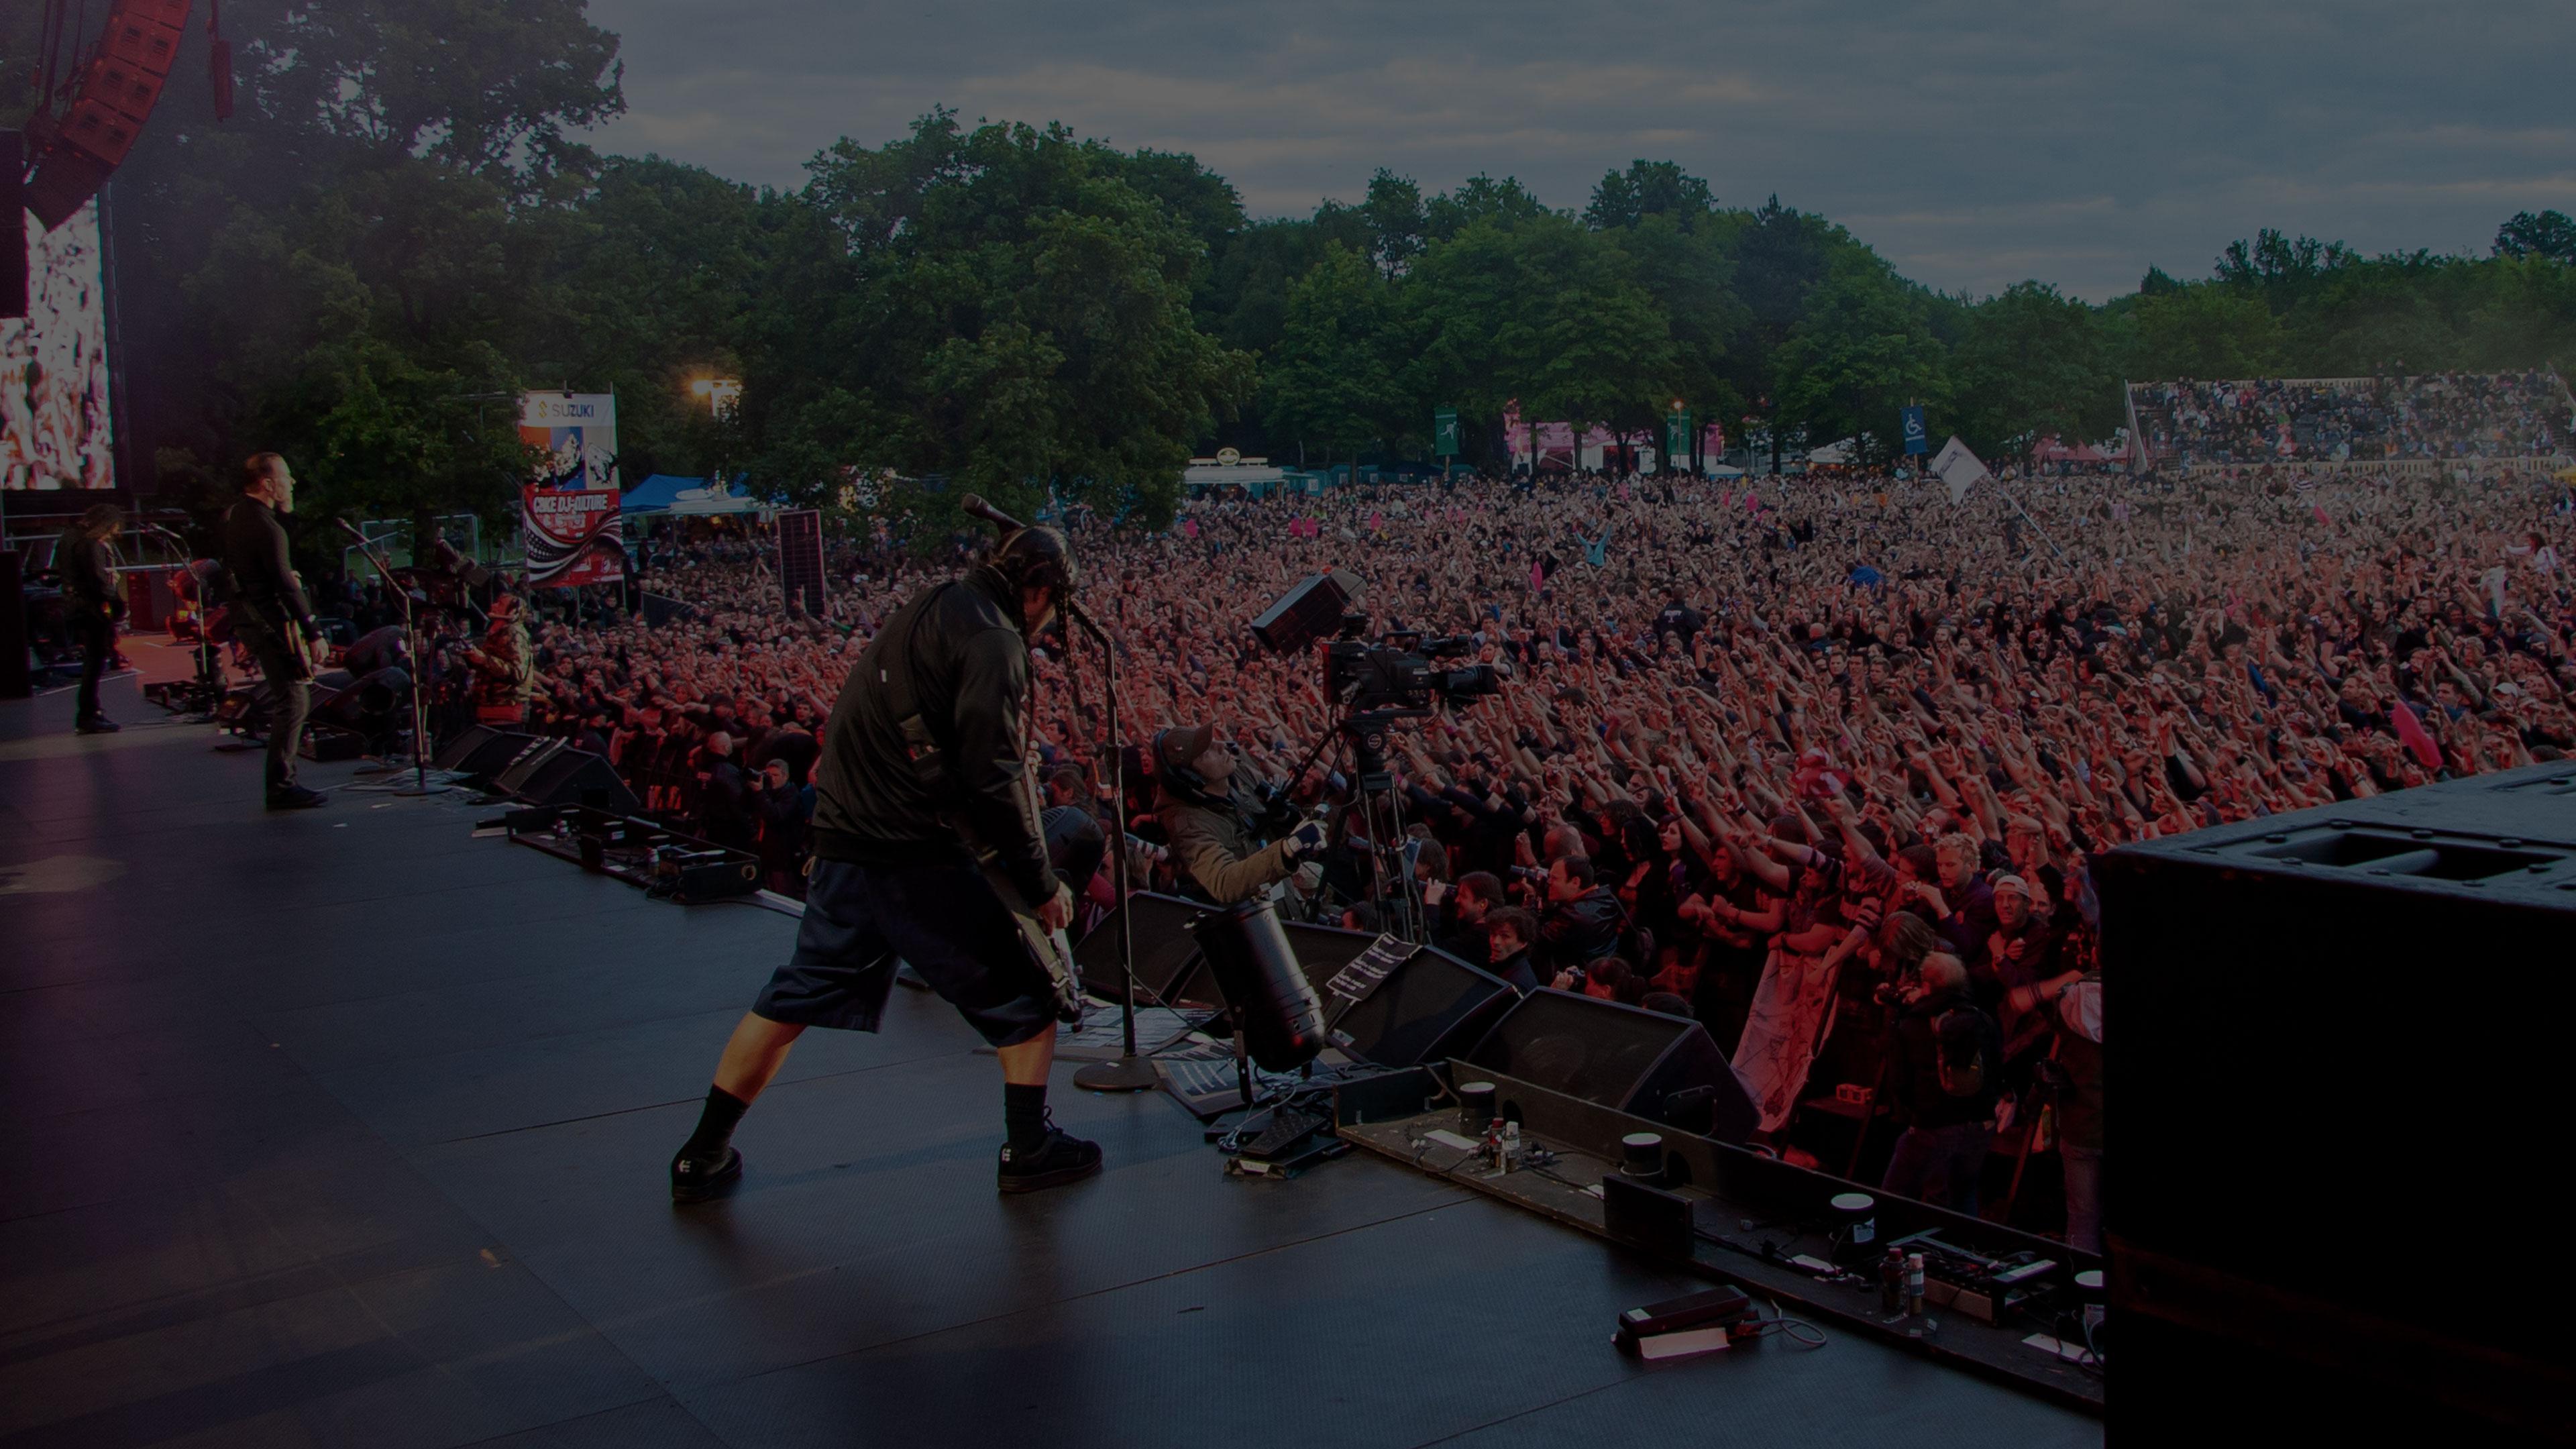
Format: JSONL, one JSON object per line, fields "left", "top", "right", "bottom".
{"left": 0, "top": 678, "right": 2102, "bottom": 1449}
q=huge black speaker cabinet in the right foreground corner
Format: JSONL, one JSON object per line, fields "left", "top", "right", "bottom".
{"left": 2094, "top": 763, "right": 2576, "bottom": 1444}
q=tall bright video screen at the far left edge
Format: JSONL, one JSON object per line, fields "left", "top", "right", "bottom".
{"left": 0, "top": 201, "right": 116, "bottom": 487}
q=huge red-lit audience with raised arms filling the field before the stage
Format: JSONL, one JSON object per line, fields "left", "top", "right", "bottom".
{"left": 474, "top": 445, "right": 2576, "bottom": 1243}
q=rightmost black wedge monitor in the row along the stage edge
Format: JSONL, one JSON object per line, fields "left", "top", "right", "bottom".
{"left": 1463, "top": 990, "right": 1760, "bottom": 1142}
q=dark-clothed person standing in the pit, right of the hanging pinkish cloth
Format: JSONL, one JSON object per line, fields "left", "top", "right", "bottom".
{"left": 1878, "top": 951, "right": 2004, "bottom": 1217}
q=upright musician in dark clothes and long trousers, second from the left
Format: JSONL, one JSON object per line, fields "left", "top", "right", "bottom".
{"left": 224, "top": 453, "right": 330, "bottom": 810}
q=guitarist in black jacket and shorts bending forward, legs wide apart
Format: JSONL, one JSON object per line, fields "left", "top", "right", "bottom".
{"left": 669, "top": 518, "right": 1100, "bottom": 1201}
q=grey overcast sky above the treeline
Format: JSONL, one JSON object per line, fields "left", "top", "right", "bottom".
{"left": 590, "top": 0, "right": 2576, "bottom": 302}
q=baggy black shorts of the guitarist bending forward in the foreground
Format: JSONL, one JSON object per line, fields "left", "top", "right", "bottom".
{"left": 752, "top": 861, "right": 1056, "bottom": 1046}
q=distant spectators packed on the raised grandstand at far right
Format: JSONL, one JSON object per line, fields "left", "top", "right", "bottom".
{"left": 2133, "top": 371, "right": 2571, "bottom": 467}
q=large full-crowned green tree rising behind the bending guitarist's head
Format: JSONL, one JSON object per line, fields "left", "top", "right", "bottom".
{"left": 793, "top": 113, "right": 1252, "bottom": 521}
